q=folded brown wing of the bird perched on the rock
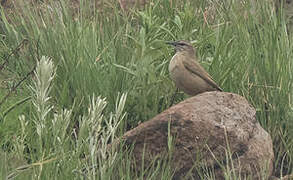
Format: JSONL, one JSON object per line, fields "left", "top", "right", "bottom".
{"left": 182, "top": 60, "right": 223, "bottom": 91}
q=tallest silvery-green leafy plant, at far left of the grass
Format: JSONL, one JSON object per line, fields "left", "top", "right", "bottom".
{"left": 7, "top": 56, "right": 72, "bottom": 179}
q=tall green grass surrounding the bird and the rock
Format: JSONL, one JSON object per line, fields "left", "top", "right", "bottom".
{"left": 0, "top": 0, "right": 293, "bottom": 179}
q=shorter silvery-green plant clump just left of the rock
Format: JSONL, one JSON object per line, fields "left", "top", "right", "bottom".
{"left": 77, "top": 93, "right": 127, "bottom": 179}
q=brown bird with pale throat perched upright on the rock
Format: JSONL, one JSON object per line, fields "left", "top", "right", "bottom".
{"left": 167, "top": 40, "right": 223, "bottom": 96}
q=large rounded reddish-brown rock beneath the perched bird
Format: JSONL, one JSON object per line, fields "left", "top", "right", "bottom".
{"left": 123, "top": 92, "right": 274, "bottom": 179}
